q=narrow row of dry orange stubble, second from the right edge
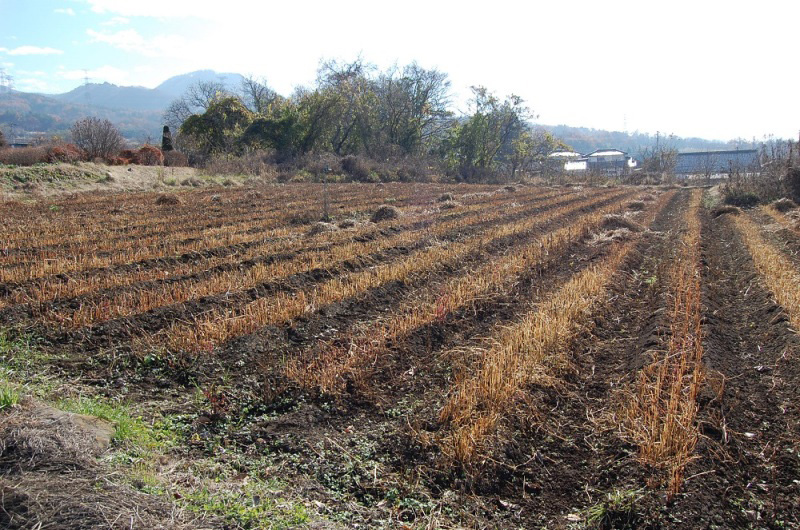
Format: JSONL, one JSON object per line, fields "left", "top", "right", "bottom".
{"left": 623, "top": 190, "right": 704, "bottom": 499}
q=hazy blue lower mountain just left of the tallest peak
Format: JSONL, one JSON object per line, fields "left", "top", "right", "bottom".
{"left": 53, "top": 83, "right": 174, "bottom": 112}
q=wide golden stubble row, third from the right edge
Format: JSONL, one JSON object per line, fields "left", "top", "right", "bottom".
{"left": 440, "top": 189, "right": 672, "bottom": 464}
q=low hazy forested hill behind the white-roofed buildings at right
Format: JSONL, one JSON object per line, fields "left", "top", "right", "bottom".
{"left": 540, "top": 125, "right": 752, "bottom": 156}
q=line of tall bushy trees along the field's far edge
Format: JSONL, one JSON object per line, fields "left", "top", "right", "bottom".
{"left": 164, "top": 59, "right": 562, "bottom": 181}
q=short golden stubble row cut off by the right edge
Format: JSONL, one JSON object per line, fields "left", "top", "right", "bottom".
{"left": 733, "top": 210, "right": 800, "bottom": 329}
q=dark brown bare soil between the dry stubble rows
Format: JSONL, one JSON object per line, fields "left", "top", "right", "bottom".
{"left": 0, "top": 185, "right": 800, "bottom": 529}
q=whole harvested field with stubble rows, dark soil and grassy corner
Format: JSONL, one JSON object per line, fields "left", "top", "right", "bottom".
{"left": 0, "top": 180, "right": 800, "bottom": 529}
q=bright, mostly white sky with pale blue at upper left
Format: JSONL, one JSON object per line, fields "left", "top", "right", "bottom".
{"left": 0, "top": 0, "right": 800, "bottom": 140}
